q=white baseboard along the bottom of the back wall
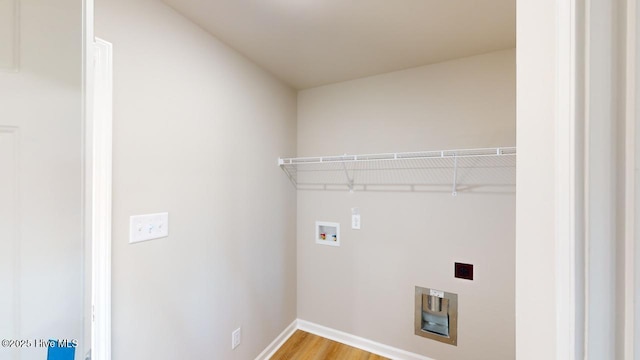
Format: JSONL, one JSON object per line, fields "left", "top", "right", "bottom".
{"left": 298, "top": 319, "right": 434, "bottom": 360}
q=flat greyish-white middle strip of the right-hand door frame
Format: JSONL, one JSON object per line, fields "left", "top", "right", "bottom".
{"left": 585, "top": 1, "right": 620, "bottom": 359}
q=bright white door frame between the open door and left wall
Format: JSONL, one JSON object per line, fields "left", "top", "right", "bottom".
{"left": 82, "top": 0, "right": 113, "bottom": 360}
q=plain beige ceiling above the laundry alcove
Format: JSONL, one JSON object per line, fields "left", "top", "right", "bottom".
{"left": 163, "top": 0, "right": 516, "bottom": 89}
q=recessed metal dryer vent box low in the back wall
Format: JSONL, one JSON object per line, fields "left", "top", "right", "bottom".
{"left": 415, "top": 286, "right": 458, "bottom": 346}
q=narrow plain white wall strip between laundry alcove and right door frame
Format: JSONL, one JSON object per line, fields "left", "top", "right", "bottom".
{"left": 516, "top": 0, "right": 557, "bottom": 360}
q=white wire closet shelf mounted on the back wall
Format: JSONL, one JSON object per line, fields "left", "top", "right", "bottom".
{"left": 278, "top": 147, "right": 516, "bottom": 195}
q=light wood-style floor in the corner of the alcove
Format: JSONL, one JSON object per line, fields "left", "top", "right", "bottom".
{"left": 271, "top": 330, "right": 388, "bottom": 360}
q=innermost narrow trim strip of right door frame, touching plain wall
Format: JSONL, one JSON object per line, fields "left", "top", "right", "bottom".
{"left": 555, "top": 0, "right": 584, "bottom": 360}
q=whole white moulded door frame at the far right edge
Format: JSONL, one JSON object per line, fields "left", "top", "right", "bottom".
{"left": 552, "top": 0, "right": 640, "bottom": 360}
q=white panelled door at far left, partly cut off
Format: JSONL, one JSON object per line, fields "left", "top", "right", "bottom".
{"left": 0, "top": 0, "right": 85, "bottom": 360}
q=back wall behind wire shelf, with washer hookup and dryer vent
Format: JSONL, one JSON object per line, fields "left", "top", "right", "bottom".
{"left": 297, "top": 50, "right": 516, "bottom": 360}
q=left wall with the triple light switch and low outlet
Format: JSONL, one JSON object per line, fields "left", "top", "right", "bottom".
{"left": 96, "top": 0, "right": 296, "bottom": 360}
